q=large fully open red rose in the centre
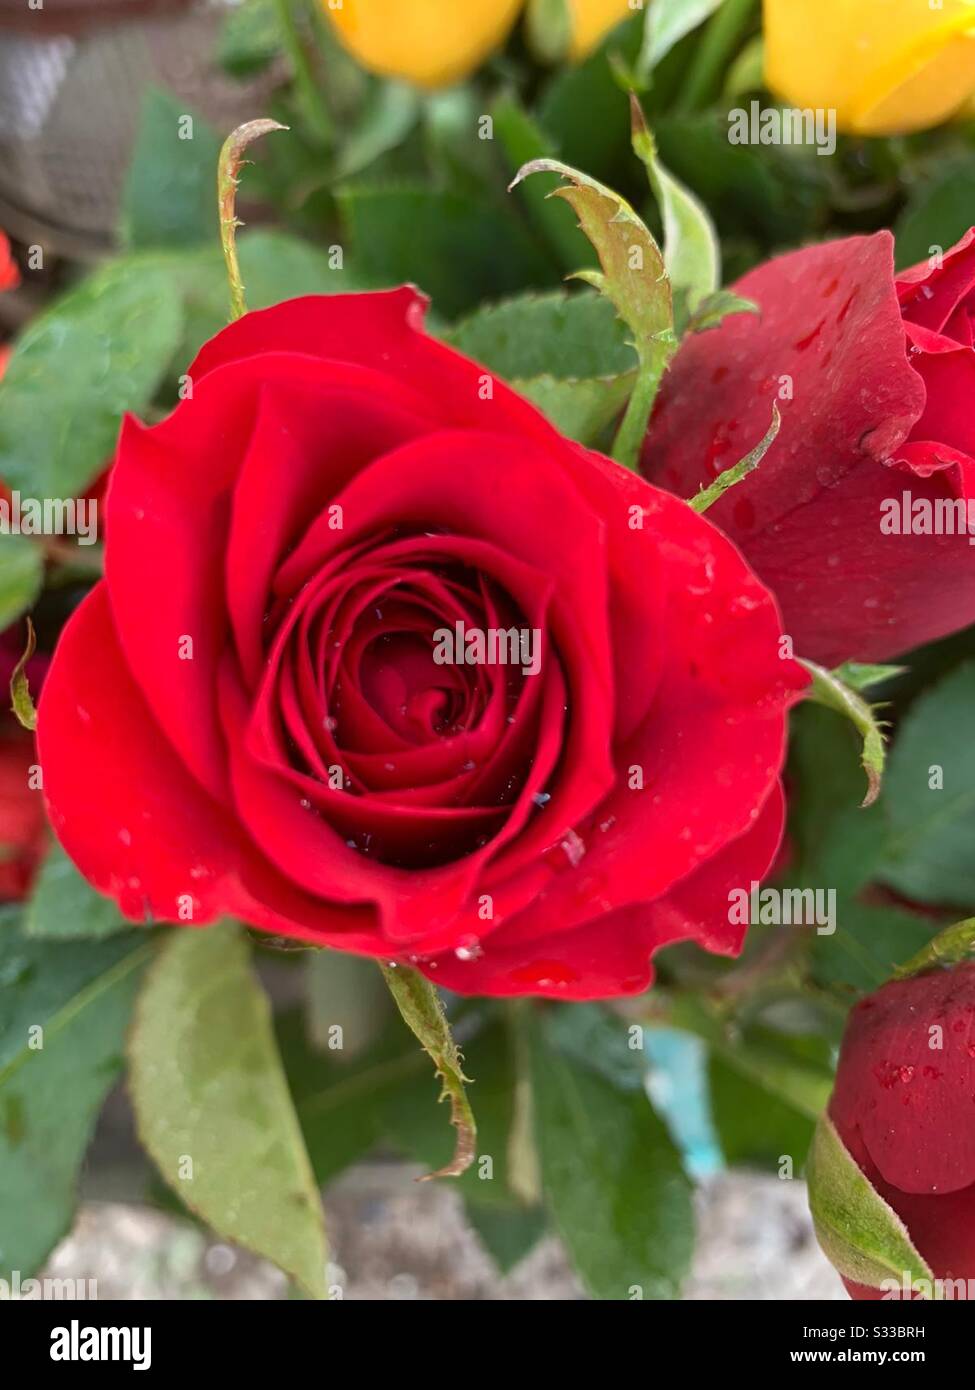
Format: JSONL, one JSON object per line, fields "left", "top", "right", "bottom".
{"left": 39, "top": 289, "right": 805, "bottom": 998}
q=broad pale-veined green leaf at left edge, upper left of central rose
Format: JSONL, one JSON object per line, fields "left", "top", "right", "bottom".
{"left": 0, "top": 261, "right": 182, "bottom": 498}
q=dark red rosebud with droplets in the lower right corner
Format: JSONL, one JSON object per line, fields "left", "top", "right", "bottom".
{"left": 829, "top": 965, "right": 975, "bottom": 1300}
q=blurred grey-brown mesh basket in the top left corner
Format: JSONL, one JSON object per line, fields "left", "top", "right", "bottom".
{"left": 0, "top": 0, "right": 281, "bottom": 273}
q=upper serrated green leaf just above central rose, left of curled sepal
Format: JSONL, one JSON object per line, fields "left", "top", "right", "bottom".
{"left": 446, "top": 291, "right": 637, "bottom": 381}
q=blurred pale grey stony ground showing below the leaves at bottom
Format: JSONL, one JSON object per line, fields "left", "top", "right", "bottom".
{"left": 46, "top": 1162, "right": 846, "bottom": 1301}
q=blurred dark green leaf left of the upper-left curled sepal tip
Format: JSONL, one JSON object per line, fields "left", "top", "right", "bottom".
{"left": 122, "top": 88, "right": 220, "bottom": 249}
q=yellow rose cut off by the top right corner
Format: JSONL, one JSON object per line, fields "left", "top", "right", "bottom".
{"left": 765, "top": 0, "right": 975, "bottom": 135}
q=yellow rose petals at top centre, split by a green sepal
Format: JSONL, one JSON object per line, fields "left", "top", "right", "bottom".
{"left": 323, "top": 0, "right": 631, "bottom": 88}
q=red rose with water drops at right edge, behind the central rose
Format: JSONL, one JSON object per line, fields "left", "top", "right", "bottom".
{"left": 644, "top": 232, "right": 975, "bottom": 666}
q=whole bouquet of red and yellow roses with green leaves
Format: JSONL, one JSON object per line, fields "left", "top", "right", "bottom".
{"left": 0, "top": 0, "right": 975, "bottom": 1300}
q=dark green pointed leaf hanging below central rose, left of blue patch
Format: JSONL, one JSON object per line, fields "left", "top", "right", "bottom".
{"left": 531, "top": 1027, "right": 694, "bottom": 1300}
